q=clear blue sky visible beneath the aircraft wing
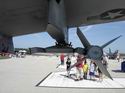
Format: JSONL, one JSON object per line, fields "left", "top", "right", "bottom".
{"left": 13, "top": 21, "right": 125, "bottom": 53}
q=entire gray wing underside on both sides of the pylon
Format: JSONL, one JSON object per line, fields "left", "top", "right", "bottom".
{"left": 0, "top": 0, "right": 125, "bottom": 36}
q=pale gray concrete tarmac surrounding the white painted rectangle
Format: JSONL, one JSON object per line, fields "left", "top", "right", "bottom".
{"left": 0, "top": 56, "right": 125, "bottom": 93}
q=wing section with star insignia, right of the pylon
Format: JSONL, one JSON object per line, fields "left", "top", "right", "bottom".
{"left": 65, "top": 0, "right": 125, "bottom": 27}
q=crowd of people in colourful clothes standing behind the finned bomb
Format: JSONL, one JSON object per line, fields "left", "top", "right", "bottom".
{"left": 60, "top": 54, "right": 108, "bottom": 81}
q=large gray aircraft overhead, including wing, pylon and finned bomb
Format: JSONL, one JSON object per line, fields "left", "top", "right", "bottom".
{"left": 0, "top": 0, "right": 125, "bottom": 79}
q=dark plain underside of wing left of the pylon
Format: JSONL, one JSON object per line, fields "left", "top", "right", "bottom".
{"left": 0, "top": 0, "right": 48, "bottom": 36}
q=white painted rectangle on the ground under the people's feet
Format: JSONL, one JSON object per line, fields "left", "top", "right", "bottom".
{"left": 37, "top": 71, "right": 125, "bottom": 89}
